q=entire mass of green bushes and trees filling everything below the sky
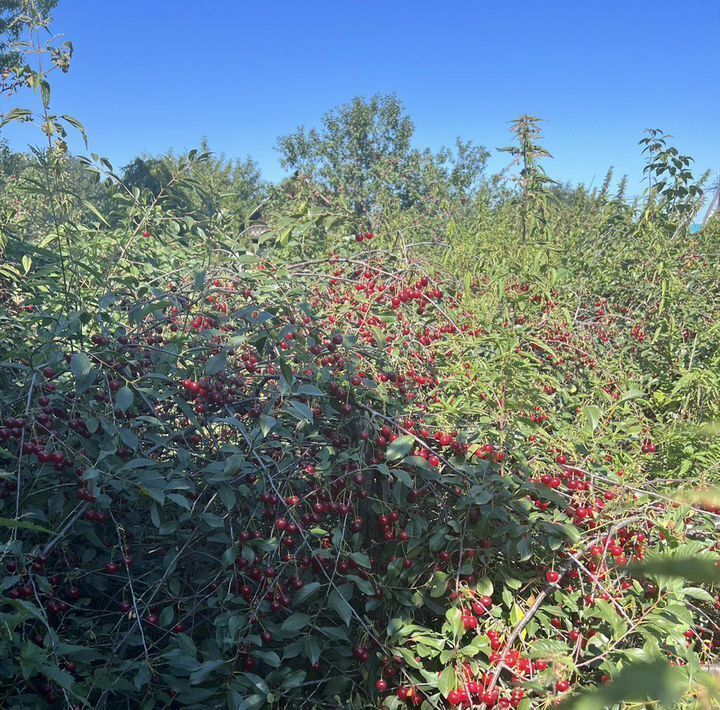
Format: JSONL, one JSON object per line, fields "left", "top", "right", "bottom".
{"left": 0, "top": 2, "right": 720, "bottom": 710}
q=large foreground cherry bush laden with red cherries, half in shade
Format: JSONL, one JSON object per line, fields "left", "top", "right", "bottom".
{"left": 0, "top": 215, "right": 719, "bottom": 708}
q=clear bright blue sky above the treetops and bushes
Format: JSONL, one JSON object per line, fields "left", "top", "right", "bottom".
{"left": 3, "top": 0, "right": 720, "bottom": 199}
